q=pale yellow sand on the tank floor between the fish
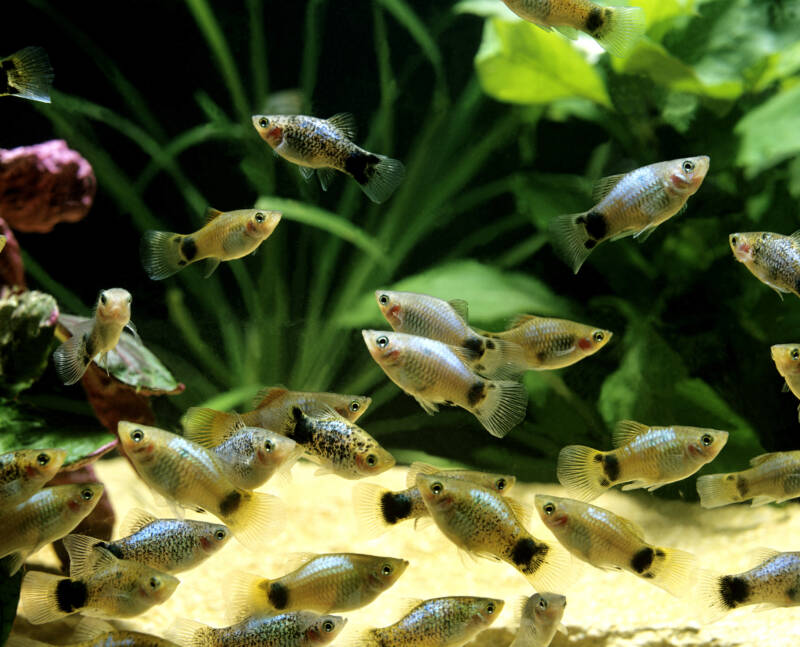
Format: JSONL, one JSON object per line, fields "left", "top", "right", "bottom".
{"left": 10, "top": 458, "right": 800, "bottom": 647}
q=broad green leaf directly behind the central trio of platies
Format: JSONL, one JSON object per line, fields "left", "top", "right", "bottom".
{"left": 339, "top": 260, "right": 571, "bottom": 328}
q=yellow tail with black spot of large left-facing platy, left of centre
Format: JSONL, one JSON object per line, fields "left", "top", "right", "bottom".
{"left": 220, "top": 489, "right": 286, "bottom": 550}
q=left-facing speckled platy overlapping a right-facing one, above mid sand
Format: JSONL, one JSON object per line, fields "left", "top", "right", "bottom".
{"left": 417, "top": 474, "right": 570, "bottom": 590}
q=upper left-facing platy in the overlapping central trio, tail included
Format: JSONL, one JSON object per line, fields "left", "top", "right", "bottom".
{"left": 375, "top": 290, "right": 525, "bottom": 378}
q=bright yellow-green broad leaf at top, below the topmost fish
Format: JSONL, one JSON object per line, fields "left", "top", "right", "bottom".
{"left": 475, "top": 18, "right": 611, "bottom": 108}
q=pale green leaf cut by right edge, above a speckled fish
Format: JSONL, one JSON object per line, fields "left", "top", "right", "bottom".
{"left": 734, "top": 86, "right": 800, "bottom": 178}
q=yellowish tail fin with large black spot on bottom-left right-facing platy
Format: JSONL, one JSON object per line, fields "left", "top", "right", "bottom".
{"left": 20, "top": 571, "right": 79, "bottom": 625}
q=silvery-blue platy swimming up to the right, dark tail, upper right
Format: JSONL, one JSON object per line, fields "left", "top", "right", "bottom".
{"left": 550, "top": 155, "right": 710, "bottom": 274}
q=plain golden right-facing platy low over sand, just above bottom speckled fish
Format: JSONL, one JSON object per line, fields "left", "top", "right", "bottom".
{"left": 231, "top": 553, "right": 408, "bottom": 619}
